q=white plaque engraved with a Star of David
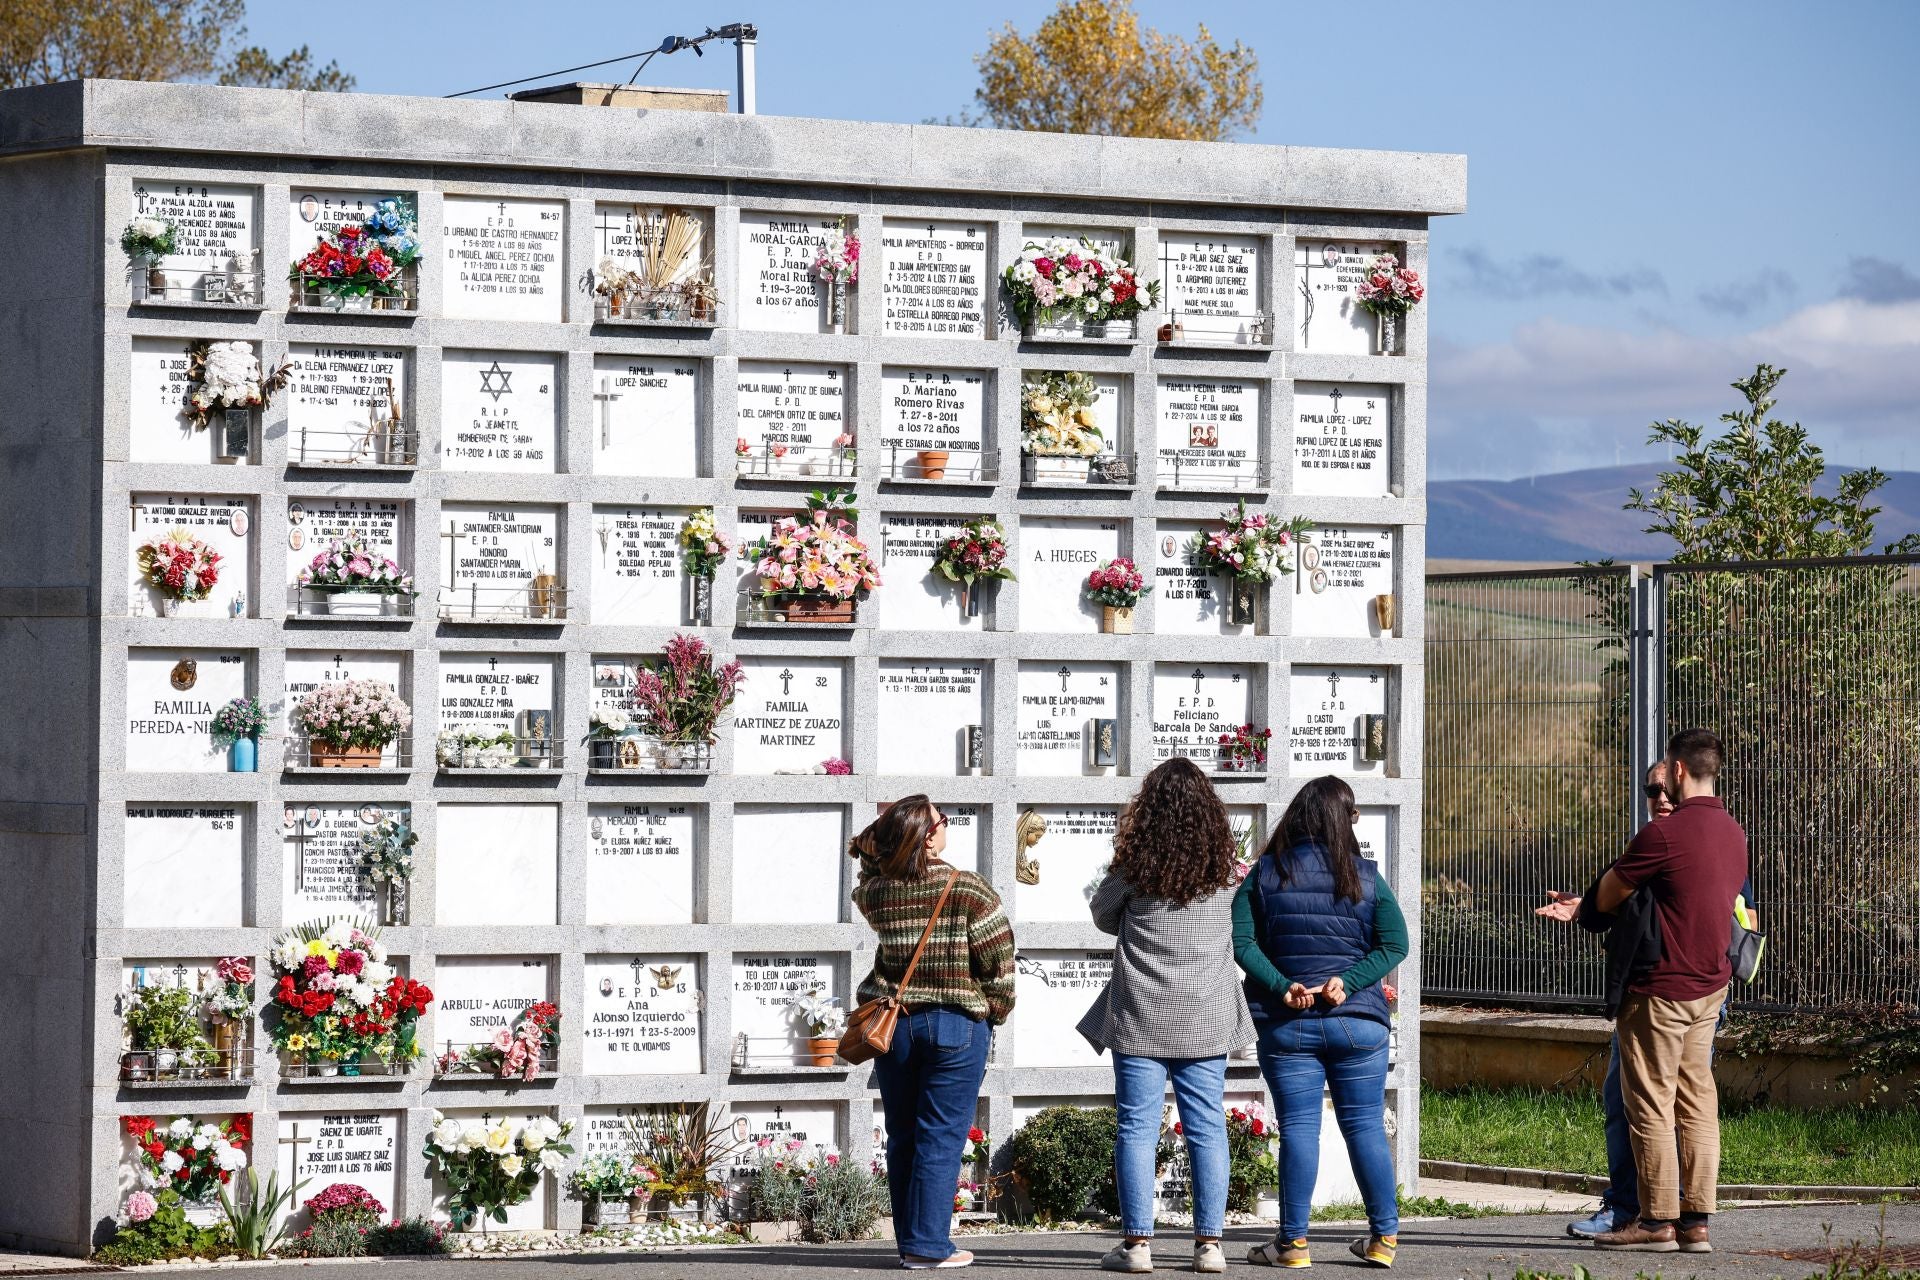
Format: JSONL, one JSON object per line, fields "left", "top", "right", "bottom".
{"left": 440, "top": 351, "right": 561, "bottom": 474}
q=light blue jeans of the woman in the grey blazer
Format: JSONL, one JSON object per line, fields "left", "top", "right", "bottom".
{"left": 1114, "top": 1054, "right": 1227, "bottom": 1240}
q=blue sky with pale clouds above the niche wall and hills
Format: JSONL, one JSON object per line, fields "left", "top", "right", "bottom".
{"left": 248, "top": 0, "right": 1920, "bottom": 478}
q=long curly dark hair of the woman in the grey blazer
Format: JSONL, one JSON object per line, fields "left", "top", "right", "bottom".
{"left": 1114, "top": 756, "right": 1235, "bottom": 904}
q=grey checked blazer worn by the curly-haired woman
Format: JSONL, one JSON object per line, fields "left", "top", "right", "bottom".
{"left": 1077, "top": 873, "right": 1256, "bottom": 1057}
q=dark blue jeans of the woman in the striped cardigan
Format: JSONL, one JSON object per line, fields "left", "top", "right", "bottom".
{"left": 874, "top": 1007, "right": 993, "bottom": 1259}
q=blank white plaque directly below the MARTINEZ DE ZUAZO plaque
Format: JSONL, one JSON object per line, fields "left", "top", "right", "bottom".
{"left": 733, "top": 804, "right": 852, "bottom": 925}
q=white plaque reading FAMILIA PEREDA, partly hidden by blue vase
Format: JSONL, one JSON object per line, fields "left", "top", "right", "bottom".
{"left": 127, "top": 649, "right": 253, "bottom": 773}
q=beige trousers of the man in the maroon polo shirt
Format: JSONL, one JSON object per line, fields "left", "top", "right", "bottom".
{"left": 1615, "top": 988, "right": 1726, "bottom": 1221}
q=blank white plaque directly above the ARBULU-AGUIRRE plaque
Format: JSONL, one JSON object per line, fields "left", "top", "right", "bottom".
{"left": 434, "top": 804, "right": 561, "bottom": 925}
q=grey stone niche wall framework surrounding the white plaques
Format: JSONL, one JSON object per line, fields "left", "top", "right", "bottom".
{"left": 0, "top": 81, "right": 1465, "bottom": 1251}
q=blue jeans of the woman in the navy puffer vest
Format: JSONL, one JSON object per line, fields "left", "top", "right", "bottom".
{"left": 1260, "top": 1013, "right": 1400, "bottom": 1240}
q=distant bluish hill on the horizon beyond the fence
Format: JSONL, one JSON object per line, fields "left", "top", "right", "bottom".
{"left": 1427, "top": 462, "right": 1920, "bottom": 562}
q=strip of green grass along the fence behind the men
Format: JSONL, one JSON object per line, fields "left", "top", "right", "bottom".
{"left": 1421, "top": 1088, "right": 1920, "bottom": 1186}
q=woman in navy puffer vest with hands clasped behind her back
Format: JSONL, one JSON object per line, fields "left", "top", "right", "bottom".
{"left": 1233, "top": 777, "right": 1407, "bottom": 1267}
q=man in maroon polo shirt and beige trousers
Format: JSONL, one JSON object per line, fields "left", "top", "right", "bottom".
{"left": 1594, "top": 729, "right": 1747, "bottom": 1253}
